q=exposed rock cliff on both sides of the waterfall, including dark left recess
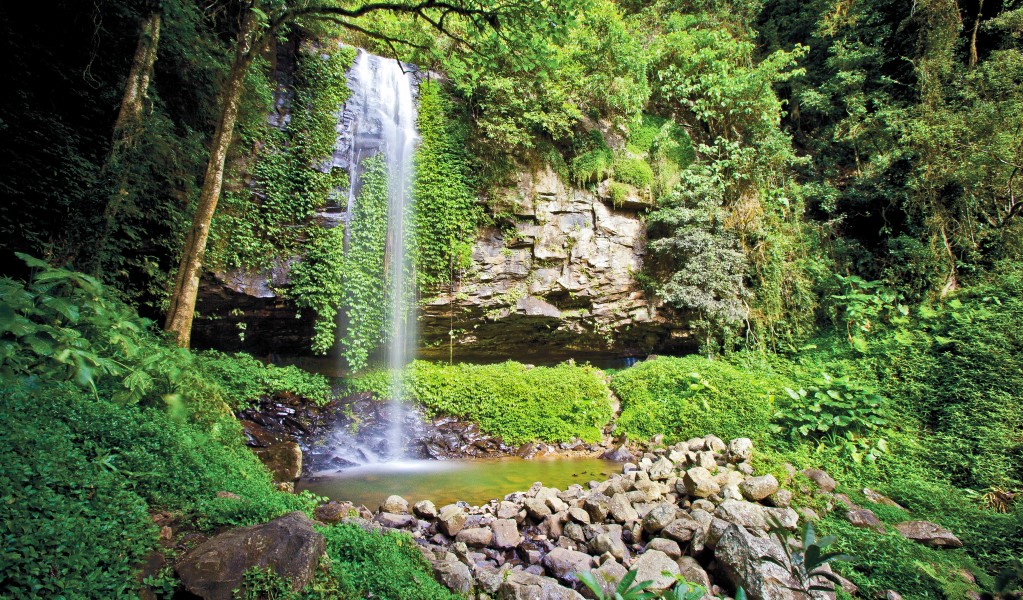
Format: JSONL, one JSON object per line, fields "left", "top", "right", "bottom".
{"left": 192, "top": 168, "right": 693, "bottom": 362}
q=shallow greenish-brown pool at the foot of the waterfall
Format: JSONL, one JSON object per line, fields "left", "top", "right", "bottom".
{"left": 298, "top": 458, "right": 621, "bottom": 510}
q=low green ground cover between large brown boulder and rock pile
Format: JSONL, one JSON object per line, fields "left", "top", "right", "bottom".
{"left": 313, "top": 524, "right": 458, "bottom": 600}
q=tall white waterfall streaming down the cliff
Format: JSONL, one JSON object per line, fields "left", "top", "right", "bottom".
{"left": 335, "top": 50, "right": 418, "bottom": 460}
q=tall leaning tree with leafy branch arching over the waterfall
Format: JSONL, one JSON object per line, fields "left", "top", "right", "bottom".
{"left": 164, "top": 0, "right": 585, "bottom": 348}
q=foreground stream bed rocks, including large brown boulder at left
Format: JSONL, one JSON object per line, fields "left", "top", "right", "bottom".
{"left": 167, "top": 421, "right": 962, "bottom": 600}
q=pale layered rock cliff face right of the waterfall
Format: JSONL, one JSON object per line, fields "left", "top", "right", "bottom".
{"left": 420, "top": 168, "right": 688, "bottom": 360}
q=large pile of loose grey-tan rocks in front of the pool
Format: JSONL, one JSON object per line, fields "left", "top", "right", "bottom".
{"left": 343, "top": 435, "right": 834, "bottom": 600}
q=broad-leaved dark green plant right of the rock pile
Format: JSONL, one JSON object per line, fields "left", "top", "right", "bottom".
{"left": 771, "top": 373, "right": 888, "bottom": 463}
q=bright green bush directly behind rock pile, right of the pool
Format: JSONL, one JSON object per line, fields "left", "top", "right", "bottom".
{"left": 611, "top": 356, "right": 791, "bottom": 441}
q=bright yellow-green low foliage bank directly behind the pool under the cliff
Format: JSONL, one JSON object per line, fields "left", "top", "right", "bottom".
{"left": 350, "top": 361, "right": 612, "bottom": 444}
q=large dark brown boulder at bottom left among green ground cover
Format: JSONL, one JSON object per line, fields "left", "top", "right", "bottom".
{"left": 175, "top": 512, "right": 326, "bottom": 600}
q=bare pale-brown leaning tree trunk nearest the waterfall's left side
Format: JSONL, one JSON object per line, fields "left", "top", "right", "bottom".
{"left": 164, "top": 13, "right": 257, "bottom": 348}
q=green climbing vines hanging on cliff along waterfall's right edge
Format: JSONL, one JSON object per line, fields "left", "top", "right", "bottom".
{"left": 412, "top": 82, "right": 482, "bottom": 285}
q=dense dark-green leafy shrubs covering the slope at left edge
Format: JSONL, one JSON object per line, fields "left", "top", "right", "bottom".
{"left": 0, "top": 260, "right": 321, "bottom": 598}
